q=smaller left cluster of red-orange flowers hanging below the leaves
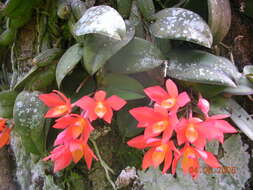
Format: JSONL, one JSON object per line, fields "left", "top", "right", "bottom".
{"left": 39, "top": 90, "right": 126, "bottom": 172}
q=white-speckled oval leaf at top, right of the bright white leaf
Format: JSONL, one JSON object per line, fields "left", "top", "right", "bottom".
{"left": 150, "top": 8, "right": 213, "bottom": 48}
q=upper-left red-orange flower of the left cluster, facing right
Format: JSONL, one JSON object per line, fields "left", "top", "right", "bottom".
{"left": 39, "top": 90, "right": 71, "bottom": 118}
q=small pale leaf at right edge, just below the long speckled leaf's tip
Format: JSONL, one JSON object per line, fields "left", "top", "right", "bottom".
{"left": 223, "top": 76, "right": 253, "bottom": 95}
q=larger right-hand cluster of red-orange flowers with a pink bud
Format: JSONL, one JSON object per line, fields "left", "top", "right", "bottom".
{"left": 128, "top": 80, "right": 236, "bottom": 178}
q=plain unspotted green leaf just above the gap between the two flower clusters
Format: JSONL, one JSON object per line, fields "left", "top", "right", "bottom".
{"left": 101, "top": 74, "right": 145, "bottom": 100}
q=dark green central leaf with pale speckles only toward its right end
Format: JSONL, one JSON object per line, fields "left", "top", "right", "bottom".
{"left": 105, "top": 37, "right": 164, "bottom": 73}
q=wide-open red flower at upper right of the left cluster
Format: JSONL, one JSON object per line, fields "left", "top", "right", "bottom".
{"left": 74, "top": 90, "right": 126, "bottom": 123}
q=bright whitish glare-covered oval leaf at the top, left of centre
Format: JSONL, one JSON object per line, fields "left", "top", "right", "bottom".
{"left": 74, "top": 5, "right": 126, "bottom": 40}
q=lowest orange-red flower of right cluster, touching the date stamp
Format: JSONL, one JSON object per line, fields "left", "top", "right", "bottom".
{"left": 172, "top": 144, "right": 220, "bottom": 178}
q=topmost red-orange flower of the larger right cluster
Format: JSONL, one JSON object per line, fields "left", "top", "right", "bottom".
{"left": 144, "top": 79, "right": 190, "bottom": 112}
